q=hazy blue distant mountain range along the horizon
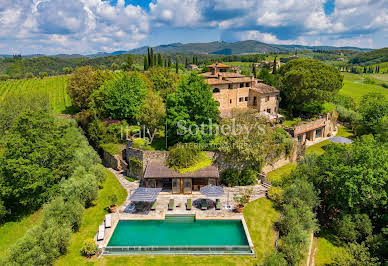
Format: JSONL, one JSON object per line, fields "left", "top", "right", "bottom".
{"left": 0, "top": 40, "right": 372, "bottom": 58}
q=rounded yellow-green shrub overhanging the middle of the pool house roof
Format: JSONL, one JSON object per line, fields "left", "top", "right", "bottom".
{"left": 167, "top": 143, "right": 201, "bottom": 169}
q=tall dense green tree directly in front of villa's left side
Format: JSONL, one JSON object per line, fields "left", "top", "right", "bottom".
{"left": 166, "top": 73, "right": 220, "bottom": 144}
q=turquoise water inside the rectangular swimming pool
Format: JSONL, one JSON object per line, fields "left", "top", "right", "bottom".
{"left": 108, "top": 216, "right": 248, "bottom": 248}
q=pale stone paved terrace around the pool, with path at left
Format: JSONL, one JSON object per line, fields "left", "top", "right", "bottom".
{"left": 98, "top": 169, "right": 266, "bottom": 255}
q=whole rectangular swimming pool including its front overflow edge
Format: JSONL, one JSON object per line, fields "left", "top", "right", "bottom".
{"left": 104, "top": 215, "right": 253, "bottom": 255}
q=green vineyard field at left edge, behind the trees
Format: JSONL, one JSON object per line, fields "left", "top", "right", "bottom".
{"left": 0, "top": 76, "right": 71, "bottom": 114}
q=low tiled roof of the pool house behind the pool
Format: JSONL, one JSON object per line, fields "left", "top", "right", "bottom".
{"left": 144, "top": 160, "right": 220, "bottom": 178}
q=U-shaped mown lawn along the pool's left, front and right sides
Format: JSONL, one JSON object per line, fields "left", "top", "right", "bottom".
{"left": 56, "top": 194, "right": 280, "bottom": 265}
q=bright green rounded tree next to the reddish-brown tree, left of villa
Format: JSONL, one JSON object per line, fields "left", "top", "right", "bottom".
{"left": 92, "top": 72, "right": 148, "bottom": 123}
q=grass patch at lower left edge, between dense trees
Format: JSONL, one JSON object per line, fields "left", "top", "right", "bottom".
{"left": 0, "top": 210, "right": 42, "bottom": 257}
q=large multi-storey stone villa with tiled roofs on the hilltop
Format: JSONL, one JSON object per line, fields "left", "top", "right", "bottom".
{"left": 201, "top": 63, "right": 279, "bottom": 116}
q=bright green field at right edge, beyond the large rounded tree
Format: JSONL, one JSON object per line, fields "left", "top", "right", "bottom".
{"left": 339, "top": 73, "right": 388, "bottom": 102}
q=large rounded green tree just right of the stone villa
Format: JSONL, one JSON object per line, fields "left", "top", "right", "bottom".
{"left": 279, "top": 59, "right": 343, "bottom": 114}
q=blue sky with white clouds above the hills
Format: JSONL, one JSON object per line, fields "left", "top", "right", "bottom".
{"left": 0, "top": 0, "right": 388, "bottom": 54}
